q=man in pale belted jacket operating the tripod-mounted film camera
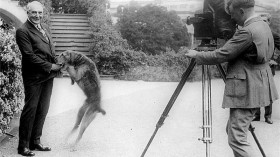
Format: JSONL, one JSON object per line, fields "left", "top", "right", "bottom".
{"left": 186, "top": 0, "right": 278, "bottom": 157}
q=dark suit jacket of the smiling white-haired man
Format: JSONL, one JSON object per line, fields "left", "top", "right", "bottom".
{"left": 16, "top": 20, "right": 57, "bottom": 85}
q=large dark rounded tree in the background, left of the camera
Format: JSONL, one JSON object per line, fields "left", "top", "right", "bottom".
{"left": 117, "top": 5, "right": 189, "bottom": 55}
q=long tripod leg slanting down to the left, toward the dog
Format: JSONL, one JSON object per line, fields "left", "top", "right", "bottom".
{"left": 141, "top": 58, "right": 196, "bottom": 157}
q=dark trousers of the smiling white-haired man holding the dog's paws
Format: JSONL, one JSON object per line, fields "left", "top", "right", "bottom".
{"left": 18, "top": 79, "right": 53, "bottom": 148}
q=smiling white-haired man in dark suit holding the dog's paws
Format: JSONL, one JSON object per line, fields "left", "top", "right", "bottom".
{"left": 16, "top": 1, "right": 61, "bottom": 156}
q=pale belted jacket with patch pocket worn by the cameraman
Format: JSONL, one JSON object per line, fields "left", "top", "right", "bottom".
{"left": 195, "top": 17, "right": 278, "bottom": 108}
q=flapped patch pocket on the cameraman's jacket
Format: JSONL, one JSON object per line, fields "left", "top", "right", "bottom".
{"left": 225, "top": 74, "right": 247, "bottom": 97}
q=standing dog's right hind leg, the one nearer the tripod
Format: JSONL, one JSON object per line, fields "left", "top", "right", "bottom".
{"left": 75, "top": 107, "right": 97, "bottom": 145}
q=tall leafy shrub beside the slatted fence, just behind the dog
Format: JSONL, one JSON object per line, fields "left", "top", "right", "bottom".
{"left": 80, "top": 0, "right": 133, "bottom": 75}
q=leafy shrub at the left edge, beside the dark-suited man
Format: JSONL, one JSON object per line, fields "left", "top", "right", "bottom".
{"left": 0, "top": 29, "right": 24, "bottom": 135}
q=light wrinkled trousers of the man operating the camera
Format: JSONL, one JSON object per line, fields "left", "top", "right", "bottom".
{"left": 227, "top": 108, "right": 257, "bottom": 157}
